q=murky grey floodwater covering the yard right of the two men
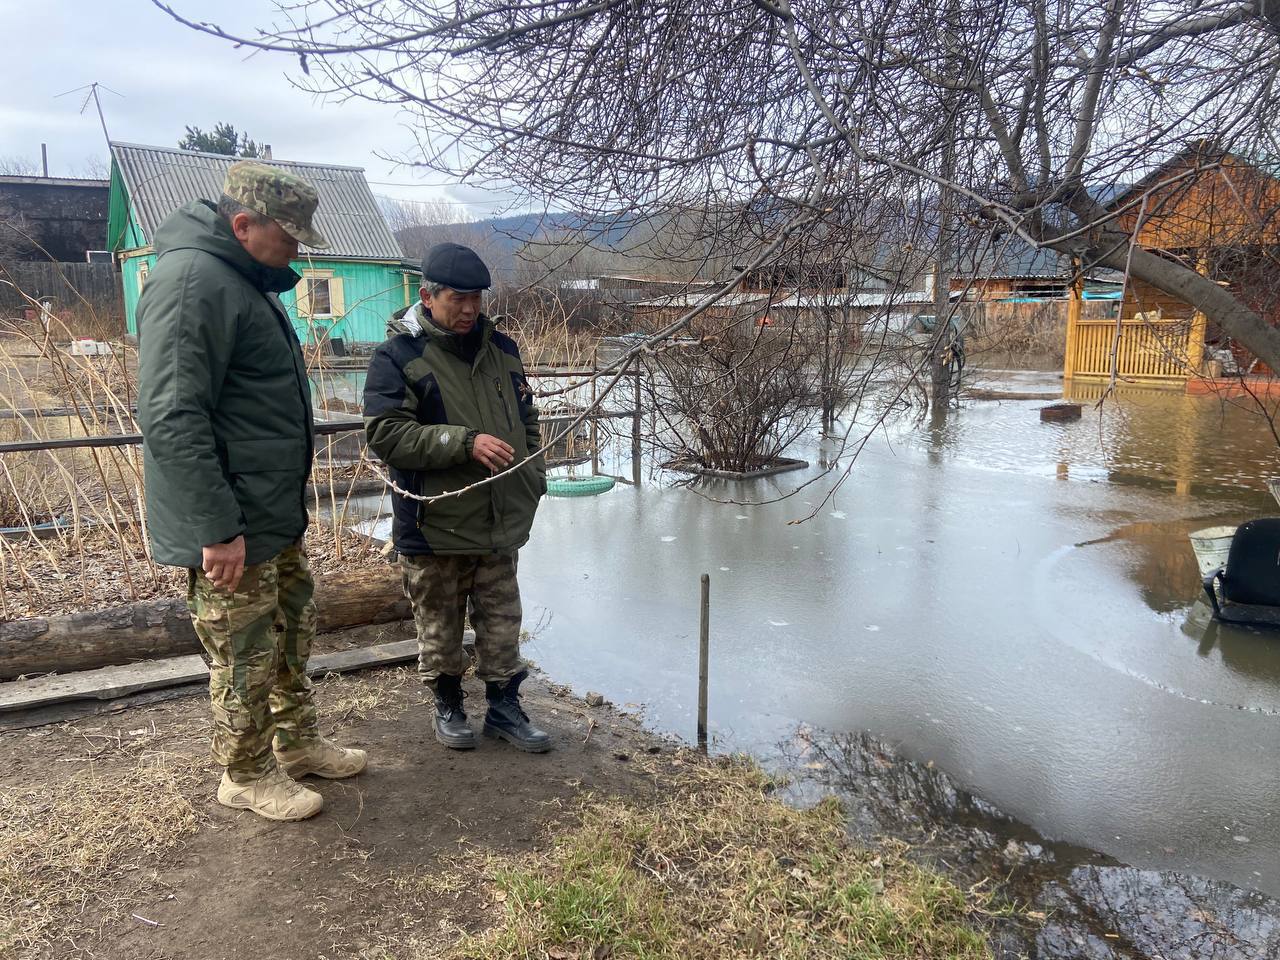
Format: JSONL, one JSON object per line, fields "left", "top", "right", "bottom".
{"left": 345, "top": 374, "right": 1280, "bottom": 896}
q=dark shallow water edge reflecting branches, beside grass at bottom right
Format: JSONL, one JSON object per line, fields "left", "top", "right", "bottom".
{"left": 783, "top": 730, "right": 1280, "bottom": 960}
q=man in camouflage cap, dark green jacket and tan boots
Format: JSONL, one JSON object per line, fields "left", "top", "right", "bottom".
{"left": 138, "top": 161, "right": 366, "bottom": 820}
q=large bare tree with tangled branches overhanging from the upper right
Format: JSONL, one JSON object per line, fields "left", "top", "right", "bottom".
{"left": 157, "top": 0, "right": 1280, "bottom": 367}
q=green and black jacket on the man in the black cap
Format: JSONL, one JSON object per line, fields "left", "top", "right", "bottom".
{"left": 365, "top": 300, "right": 547, "bottom": 556}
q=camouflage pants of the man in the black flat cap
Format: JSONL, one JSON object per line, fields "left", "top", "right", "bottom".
{"left": 401, "top": 554, "right": 525, "bottom": 685}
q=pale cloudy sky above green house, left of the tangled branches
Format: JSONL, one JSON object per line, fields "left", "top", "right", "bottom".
{"left": 0, "top": 0, "right": 506, "bottom": 216}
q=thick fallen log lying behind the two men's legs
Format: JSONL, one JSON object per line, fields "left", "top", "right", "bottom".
{"left": 0, "top": 564, "right": 412, "bottom": 680}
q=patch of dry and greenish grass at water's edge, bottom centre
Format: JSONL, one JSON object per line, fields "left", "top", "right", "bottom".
{"left": 366, "top": 759, "right": 992, "bottom": 960}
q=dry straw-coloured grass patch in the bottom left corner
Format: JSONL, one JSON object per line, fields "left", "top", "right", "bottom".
{"left": 0, "top": 735, "right": 207, "bottom": 956}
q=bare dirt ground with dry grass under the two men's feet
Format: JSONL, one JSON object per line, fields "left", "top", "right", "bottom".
{"left": 0, "top": 668, "right": 678, "bottom": 960}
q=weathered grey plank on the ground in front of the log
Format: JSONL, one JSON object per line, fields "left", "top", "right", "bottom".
{"left": 0, "top": 640, "right": 435, "bottom": 713}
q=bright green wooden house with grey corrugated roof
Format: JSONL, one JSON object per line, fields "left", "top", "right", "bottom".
{"left": 108, "top": 143, "right": 421, "bottom": 346}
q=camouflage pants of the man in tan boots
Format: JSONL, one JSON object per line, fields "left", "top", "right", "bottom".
{"left": 187, "top": 544, "right": 316, "bottom": 782}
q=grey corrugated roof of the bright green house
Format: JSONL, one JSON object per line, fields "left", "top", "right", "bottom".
{"left": 111, "top": 143, "right": 404, "bottom": 260}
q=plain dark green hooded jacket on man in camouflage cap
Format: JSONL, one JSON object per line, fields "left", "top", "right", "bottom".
{"left": 137, "top": 200, "right": 315, "bottom": 567}
